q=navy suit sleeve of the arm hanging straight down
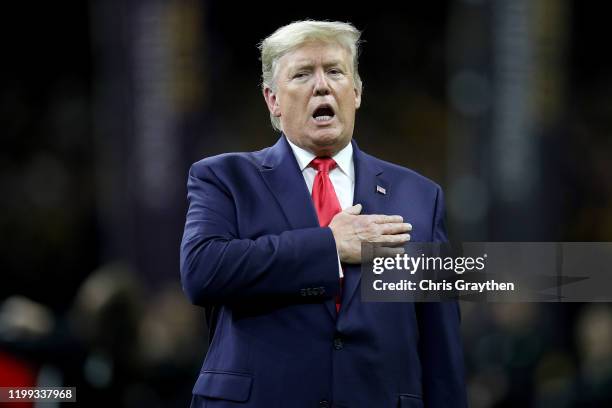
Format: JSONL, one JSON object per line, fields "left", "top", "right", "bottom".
{"left": 416, "top": 187, "right": 467, "bottom": 408}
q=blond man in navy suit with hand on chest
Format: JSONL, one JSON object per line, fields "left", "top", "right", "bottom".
{"left": 181, "top": 21, "right": 467, "bottom": 408}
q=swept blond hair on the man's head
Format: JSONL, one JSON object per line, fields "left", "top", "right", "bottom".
{"left": 259, "top": 20, "right": 363, "bottom": 131}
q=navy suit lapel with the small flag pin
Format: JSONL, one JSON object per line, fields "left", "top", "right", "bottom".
{"left": 342, "top": 141, "right": 389, "bottom": 310}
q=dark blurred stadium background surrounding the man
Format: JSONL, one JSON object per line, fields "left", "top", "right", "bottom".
{"left": 0, "top": 0, "right": 612, "bottom": 408}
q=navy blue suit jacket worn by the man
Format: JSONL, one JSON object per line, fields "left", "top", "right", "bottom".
{"left": 181, "top": 136, "right": 467, "bottom": 408}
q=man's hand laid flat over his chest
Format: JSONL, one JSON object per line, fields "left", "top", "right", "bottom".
{"left": 329, "top": 204, "right": 412, "bottom": 263}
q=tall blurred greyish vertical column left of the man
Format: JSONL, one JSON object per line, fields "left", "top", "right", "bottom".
{"left": 92, "top": 0, "right": 206, "bottom": 287}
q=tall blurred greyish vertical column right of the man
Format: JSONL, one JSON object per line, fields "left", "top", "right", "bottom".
{"left": 447, "top": 0, "right": 568, "bottom": 241}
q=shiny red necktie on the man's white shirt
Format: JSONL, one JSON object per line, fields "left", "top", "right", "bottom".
{"left": 310, "top": 157, "right": 342, "bottom": 312}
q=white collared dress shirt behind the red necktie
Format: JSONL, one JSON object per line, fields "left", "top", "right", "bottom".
{"left": 287, "top": 138, "right": 355, "bottom": 278}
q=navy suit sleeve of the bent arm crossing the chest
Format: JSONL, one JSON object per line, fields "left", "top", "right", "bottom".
{"left": 181, "top": 165, "right": 339, "bottom": 305}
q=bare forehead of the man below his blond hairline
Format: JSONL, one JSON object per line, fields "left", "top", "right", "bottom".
{"left": 278, "top": 41, "right": 350, "bottom": 69}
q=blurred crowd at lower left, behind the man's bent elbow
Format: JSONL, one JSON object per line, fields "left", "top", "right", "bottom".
{"left": 0, "top": 264, "right": 207, "bottom": 407}
